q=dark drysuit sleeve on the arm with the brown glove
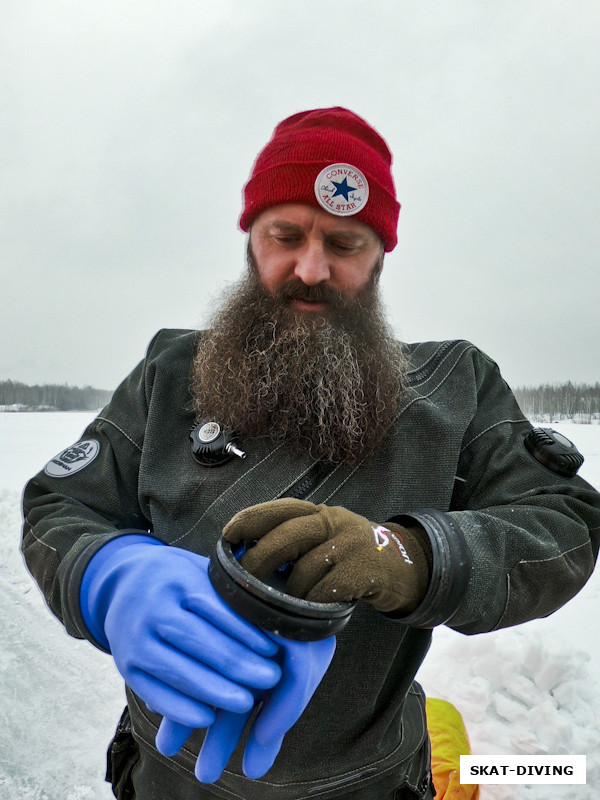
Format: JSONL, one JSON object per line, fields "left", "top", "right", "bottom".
{"left": 395, "top": 348, "right": 600, "bottom": 634}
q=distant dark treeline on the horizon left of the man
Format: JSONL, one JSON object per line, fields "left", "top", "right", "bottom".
{"left": 0, "top": 381, "right": 112, "bottom": 411}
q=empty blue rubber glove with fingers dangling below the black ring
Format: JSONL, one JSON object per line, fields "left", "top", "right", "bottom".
{"left": 156, "top": 634, "right": 335, "bottom": 783}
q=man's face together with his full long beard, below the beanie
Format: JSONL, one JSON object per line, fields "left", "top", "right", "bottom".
{"left": 191, "top": 204, "right": 407, "bottom": 464}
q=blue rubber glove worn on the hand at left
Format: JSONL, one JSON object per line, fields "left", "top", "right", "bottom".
{"left": 80, "top": 534, "right": 281, "bottom": 728}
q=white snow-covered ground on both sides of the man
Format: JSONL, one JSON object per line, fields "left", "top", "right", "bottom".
{"left": 0, "top": 413, "right": 600, "bottom": 800}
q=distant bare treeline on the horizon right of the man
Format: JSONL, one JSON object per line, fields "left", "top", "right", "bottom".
{"left": 514, "top": 381, "right": 600, "bottom": 422}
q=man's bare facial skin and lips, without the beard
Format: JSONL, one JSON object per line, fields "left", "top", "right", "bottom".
{"left": 250, "top": 203, "right": 383, "bottom": 314}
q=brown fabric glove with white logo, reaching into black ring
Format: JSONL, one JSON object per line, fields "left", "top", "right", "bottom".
{"left": 223, "top": 498, "right": 431, "bottom": 615}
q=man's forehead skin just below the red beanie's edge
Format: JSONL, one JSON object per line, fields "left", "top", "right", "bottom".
{"left": 252, "top": 203, "right": 379, "bottom": 241}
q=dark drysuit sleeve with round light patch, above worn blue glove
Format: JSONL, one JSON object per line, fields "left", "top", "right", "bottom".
{"left": 21, "top": 334, "right": 158, "bottom": 641}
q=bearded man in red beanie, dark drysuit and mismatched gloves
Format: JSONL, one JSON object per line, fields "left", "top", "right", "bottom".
{"left": 23, "top": 108, "right": 600, "bottom": 800}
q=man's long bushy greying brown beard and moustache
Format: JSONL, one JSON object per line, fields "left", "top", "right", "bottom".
{"left": 191, "top": 273, "right": 406, "bottom": 464}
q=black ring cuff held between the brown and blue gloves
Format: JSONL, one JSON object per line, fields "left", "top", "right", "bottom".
{"left": 208, "top": 538, "right": 356, "bottom": 642}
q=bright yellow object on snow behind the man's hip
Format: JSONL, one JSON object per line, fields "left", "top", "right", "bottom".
{"left": 426, "top": 697, "right": 479, "bottom": 800}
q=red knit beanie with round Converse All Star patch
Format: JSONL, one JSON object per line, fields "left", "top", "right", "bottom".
{"left": 240, "top": 107, "right": 400, "bottom": 252}
